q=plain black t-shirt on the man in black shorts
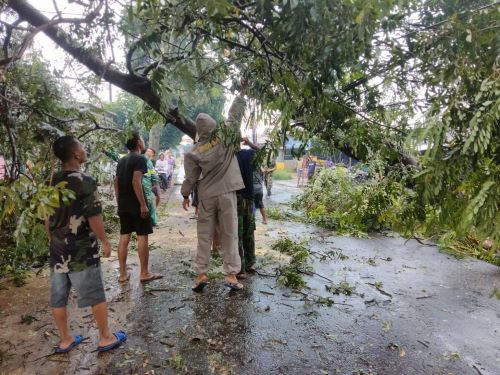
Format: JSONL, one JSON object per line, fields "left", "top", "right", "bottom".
{"left": 116, "top": 152, "right": 148, "bottom": 214}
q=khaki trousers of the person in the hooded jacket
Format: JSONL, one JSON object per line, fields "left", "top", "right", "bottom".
{"left": 194, "top": 191, "right": 241, "bottom": 274}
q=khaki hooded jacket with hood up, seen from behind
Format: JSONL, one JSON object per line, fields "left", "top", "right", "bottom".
{"left": 181, "top": 96, "right": 246, "bottom": 201}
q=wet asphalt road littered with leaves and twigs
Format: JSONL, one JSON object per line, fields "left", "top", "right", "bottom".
{"left": 2, "top": 182, "right": 500, "bottom": 375}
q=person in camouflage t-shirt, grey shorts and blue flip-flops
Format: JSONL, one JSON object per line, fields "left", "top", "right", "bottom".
{"left": 45, "top": 136, "right": 127, "bottom": 353}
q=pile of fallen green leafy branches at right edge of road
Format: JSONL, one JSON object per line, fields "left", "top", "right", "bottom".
{"left": 292, "top": 167, "right": 500, "bottom": 265}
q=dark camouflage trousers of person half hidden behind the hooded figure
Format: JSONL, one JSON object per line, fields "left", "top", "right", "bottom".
{"left": 237, "top": 195, "right": 255, "bottom": 272}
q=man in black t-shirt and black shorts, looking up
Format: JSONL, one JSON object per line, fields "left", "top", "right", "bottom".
{"left": 115, "top": 132, "right": 161, "bottom": 282}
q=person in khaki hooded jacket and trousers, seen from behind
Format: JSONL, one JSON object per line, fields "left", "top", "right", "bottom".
{"left": 181, "top": 95, "right": 246, "bottom": 291}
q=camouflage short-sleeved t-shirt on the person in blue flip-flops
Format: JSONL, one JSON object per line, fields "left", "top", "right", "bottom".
{"left": 49, "top": 171, "right": 102, "bottom": 273}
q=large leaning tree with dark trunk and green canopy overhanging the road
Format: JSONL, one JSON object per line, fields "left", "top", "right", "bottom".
{"left": 0, "top": 0, "right": 500, "bottom": 253}
